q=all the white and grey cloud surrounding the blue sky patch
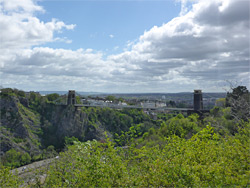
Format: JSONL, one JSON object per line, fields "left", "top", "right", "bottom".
{"left": 0, "top": 0, "right": 250, "bottom": 92}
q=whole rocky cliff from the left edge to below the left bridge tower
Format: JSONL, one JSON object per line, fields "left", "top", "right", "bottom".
{"left": 0, "top": 96, "right": 104, "bottom": 156}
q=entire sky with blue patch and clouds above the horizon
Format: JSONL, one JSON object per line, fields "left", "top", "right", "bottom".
{"left": 0, "top": 0, "right": 250, "bottom": 93}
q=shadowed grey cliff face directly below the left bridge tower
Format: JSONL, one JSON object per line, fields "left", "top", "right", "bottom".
{"left": 42, "top": 104, "right": 104, "bottom": 147}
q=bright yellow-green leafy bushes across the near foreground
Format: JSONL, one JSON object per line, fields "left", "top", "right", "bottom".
{"left": 6, "top": 123, "right": 247, "bottom": 187}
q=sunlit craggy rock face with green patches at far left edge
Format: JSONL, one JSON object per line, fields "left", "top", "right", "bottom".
{"left": 0, "top": 96, "right": 40, "bottom": 155}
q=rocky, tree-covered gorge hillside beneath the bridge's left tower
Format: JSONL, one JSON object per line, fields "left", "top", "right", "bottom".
{"left": 0, "top": 89, "right": 151, "bottom": 167}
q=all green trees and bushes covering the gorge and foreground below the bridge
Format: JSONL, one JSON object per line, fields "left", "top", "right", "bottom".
{"left": 0, "top": 87, "right": 250, "bottom": 187}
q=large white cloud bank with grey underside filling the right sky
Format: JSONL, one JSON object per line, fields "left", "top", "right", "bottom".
{"left": 106, "top": 0, "right": 250, "bottom": 90}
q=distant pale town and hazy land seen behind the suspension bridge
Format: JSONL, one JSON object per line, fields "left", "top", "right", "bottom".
{"left": 38, "top": 91, "right": 226, "bottom": 110}
